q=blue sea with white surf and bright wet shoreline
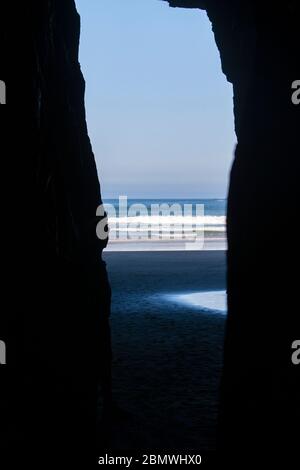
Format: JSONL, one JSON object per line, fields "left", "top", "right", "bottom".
{"left": 103, "top": 196, "right": 227, "bottom": 251}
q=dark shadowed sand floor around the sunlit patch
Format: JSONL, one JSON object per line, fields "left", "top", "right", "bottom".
{"left": 104, "top": 251, "right": 225, "bottom": 451}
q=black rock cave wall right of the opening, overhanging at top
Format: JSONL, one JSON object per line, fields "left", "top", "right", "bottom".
{"left": 169, "top": 0, "right": 300, "bottom": 458}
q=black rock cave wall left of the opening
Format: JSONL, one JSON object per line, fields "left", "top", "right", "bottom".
{"left": 0, "top": 0, "right": 110, "bottom": 464}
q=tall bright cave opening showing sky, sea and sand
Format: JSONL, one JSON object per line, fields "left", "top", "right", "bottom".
{"left": 76, "top": 0, "right": 236, "bottom": 449}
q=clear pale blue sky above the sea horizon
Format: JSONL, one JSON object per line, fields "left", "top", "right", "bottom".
{"left": 76, "top": 0, "right": 236, "bottom": 198}
